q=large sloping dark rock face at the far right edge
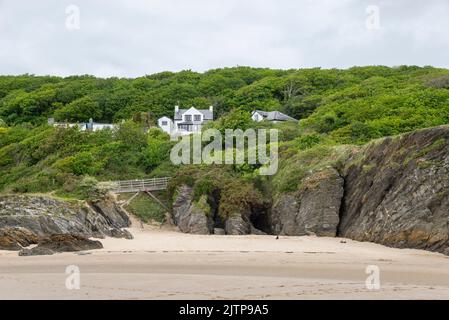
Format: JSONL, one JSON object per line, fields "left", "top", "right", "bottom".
{"left": 339, "top": 127, "right": 449, "bottom": 254}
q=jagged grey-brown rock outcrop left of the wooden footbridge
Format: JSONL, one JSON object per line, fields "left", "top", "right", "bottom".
{"left": 0, "top": 195, "right": 133, "bottom": 254}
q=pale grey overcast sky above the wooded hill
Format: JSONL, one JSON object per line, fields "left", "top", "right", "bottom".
{"left": 0, "top": 0, "right": 449, "bottom": 77}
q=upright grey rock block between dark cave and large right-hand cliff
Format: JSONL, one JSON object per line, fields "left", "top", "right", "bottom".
{"left": 270, "top": 168, "right": 344, "bottom": 237}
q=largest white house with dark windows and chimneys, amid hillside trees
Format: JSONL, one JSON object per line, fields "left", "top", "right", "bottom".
{"left": 158, "top": 106, "right": 214, "bottom": 136}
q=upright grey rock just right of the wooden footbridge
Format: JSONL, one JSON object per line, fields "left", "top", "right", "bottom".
{"left": 173, "top": 185, "right": 212, "bottom": 235}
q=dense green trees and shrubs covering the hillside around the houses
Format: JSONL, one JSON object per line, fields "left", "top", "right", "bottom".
{"left": 0, "top": 66, "right": 449, "bottom": 220}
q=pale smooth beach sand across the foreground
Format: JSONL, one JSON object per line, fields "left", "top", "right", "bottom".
{"left": 0, "top": 228, "right": 449, "bottom": 299}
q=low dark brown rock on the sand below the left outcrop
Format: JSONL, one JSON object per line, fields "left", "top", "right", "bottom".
{"left": 19, "top": 234, "right": 103, "bottom": 256}
